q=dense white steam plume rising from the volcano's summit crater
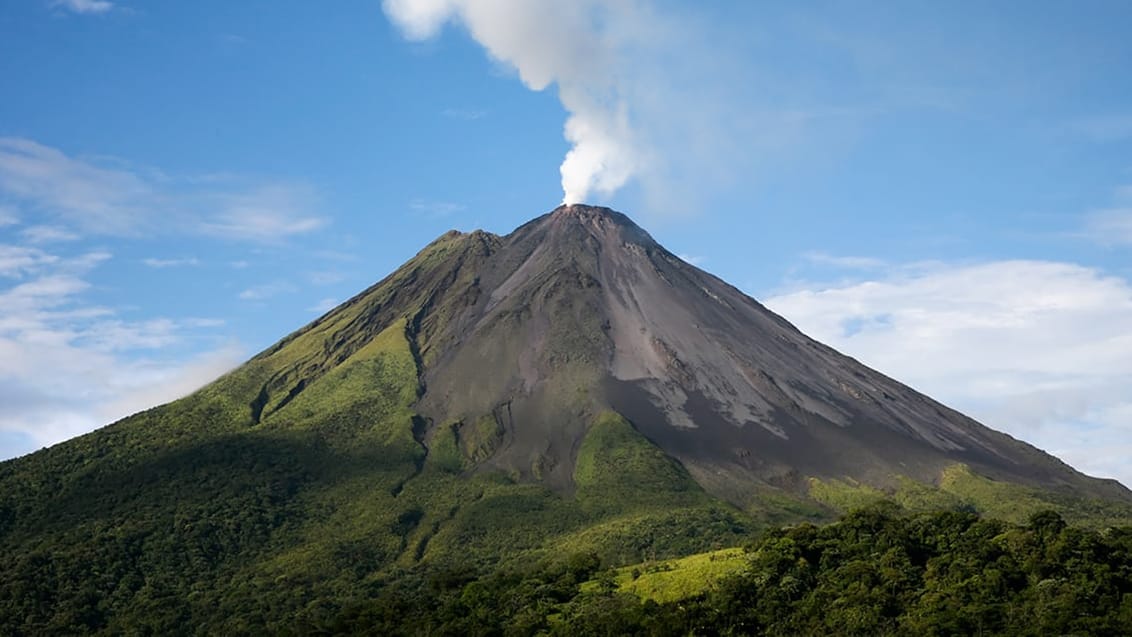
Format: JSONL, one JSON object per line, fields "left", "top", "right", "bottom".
{"left": 384, "top": 0, "right": 662, "bottom": 204}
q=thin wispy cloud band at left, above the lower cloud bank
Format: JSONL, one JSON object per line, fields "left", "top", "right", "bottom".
{"left": 0, "top": 137, "right": 327, "bottom": 243}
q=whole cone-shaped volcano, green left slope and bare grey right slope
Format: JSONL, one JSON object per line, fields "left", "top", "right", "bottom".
{"left": 0, "top": 205, "right": 1132, "bottom": 634}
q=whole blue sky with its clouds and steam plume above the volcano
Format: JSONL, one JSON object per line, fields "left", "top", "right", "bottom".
{"left": 0, "top": 0, "right": 1132, "bottom": 484}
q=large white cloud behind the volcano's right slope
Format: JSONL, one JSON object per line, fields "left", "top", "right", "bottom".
{"left": 765, "top": 261, "right": 1132, "bottom": 484}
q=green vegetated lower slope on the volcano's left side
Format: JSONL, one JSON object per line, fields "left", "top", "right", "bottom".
{"left": 0, "top": 319, "right": 752, "bottom": 634}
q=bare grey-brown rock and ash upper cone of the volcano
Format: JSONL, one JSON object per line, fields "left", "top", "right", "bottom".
{"left": 300, "top": 205, "right": 1129, "bottom": 502}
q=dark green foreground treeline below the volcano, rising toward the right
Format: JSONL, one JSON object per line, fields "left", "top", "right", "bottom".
{"left": 330, "top": 507, "right": 1132, "bottom": 636}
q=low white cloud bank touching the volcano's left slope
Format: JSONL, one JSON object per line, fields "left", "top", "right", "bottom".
{"left": 0, "top": 247, "right": 241, "bottom": 457}
